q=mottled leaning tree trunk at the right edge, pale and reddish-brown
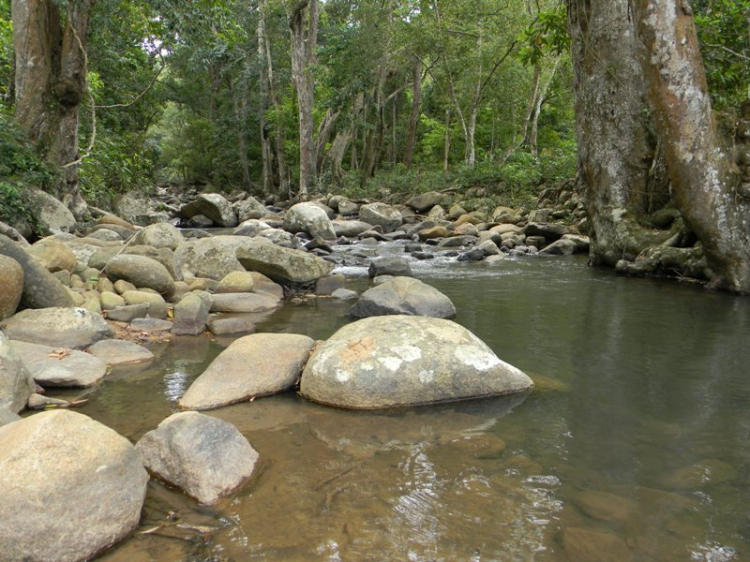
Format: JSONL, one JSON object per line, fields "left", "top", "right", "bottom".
{"left": 634, "top": 0, "right": 750, "bottom": 293}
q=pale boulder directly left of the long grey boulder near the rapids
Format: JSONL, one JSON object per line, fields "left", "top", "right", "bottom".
{"left": 176, "top": 236, "right": 249, "bottom": 281}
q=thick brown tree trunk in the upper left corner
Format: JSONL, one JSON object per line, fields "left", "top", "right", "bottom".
{"left": 11, "top": 0, "right": 95, "bottom": 208}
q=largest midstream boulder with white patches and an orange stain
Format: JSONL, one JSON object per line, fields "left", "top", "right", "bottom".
{"left": 301, "top": 316, "right": 533, "bottom": 410}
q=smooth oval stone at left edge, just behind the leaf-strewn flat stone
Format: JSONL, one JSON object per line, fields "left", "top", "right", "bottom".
{"left": 0, "top": 308, "right": 114, "bottom": 349}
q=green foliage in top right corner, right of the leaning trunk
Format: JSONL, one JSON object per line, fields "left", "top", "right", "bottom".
{"left": 694, "top": 0, "right": 750, "bottom": 108}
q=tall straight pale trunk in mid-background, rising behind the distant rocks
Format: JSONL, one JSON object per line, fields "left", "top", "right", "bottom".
{"left": 289, "top": 0, "right": 318, "bottom": 197}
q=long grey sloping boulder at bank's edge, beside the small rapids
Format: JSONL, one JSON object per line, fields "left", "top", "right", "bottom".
{"left": 237, "top": 234, "right": 334, "bottom": 283}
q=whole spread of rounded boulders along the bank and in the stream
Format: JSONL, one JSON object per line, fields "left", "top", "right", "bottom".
{"left": 0, "top": 189, "right": 588, "bottom": 560}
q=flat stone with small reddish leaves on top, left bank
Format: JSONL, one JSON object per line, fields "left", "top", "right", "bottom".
{"left": 13, "top": 341, "right": 107, "bottom": 388}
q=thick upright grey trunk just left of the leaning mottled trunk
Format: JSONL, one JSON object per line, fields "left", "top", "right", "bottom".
{"left": 568, "top": 0, "right": 671, "bottom": 265}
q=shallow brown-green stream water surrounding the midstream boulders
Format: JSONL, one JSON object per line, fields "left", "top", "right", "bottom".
{"left": 60, "top": 252, "right": 750, "bottom": 562}
